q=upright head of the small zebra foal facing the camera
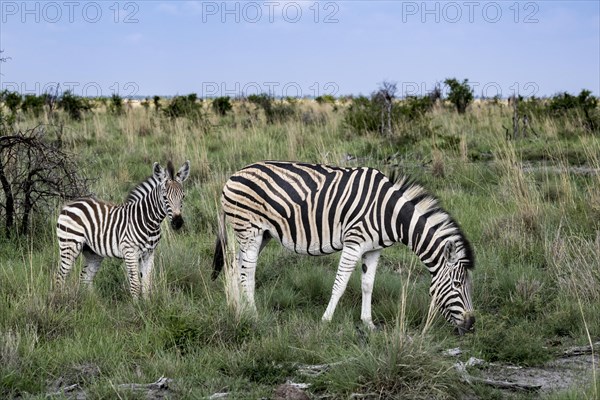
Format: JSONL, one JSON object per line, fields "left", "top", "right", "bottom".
{"left": 153, "top": 160, "right": 190, "bottom": 230}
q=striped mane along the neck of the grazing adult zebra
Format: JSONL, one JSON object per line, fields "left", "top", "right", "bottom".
{"left": 390, "top": 174, "right": 475, "bottom": 269}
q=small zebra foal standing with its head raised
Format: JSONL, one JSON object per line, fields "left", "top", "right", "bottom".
{"left": 56, "top": 161, "right": 190, "bottom": 298}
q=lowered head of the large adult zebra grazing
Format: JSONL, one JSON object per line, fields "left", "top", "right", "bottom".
{"left": 429, "top": 239, "right": 475, "bottom": 335}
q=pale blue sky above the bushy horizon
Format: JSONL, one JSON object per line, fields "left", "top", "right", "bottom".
{"left": 0, "top": 0, "right": 600, "bottom": 97}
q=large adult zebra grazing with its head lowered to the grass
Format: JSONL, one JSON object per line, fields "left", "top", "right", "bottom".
{"left": 213, "top": 161, "right": 475, "bottom": 334}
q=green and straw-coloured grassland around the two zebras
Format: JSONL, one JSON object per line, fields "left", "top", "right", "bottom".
{"left": 0, "top": 97, "right": 600, "bottom": 399}
